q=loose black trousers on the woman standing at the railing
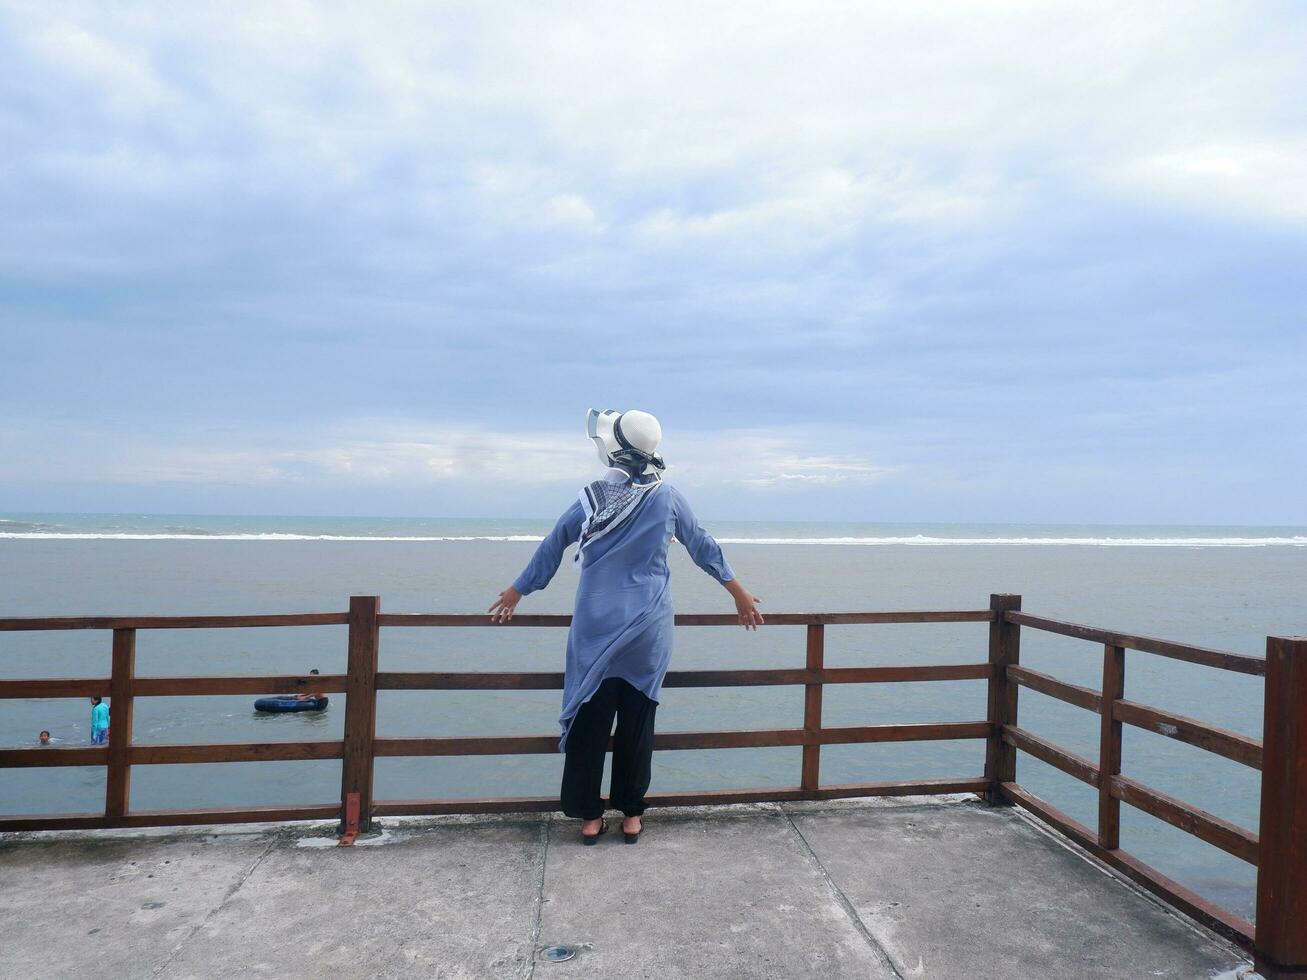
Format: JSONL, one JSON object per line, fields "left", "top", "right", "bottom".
{"left": 562, "top": 677, "right": 657, "bottom": 821}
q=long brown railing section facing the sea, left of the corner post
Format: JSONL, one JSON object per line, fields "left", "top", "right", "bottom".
{"left": 0, "top": 596, "right": 993, "bottom": 831}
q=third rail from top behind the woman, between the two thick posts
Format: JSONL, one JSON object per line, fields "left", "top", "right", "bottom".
{"left": 372, "top": 721, "right": 989, "bottom": 757}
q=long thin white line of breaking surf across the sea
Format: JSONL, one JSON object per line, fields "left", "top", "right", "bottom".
{"left": 0, "top": 531, "right": 1307, "bottom": 547}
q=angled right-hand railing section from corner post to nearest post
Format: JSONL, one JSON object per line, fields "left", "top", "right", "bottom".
{"left": 985, "top": 596, "right": 1307, "bottom": 979}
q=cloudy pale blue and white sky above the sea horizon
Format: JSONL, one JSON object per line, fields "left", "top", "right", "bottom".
{"left": 0, "top": 0, "right": 1307, "bottom": 525}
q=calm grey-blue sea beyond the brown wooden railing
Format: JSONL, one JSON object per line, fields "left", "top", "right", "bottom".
{"left": 0, "top": 514, "right": 1307, "bottom": 919}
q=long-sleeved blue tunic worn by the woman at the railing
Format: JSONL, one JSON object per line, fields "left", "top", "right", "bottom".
{"left": 512, "top": 483, "right": 735, "bottom": 751}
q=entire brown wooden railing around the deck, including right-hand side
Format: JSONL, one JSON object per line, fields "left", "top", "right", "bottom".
{"left": 0, "top": 595, "right": 1307, "bottom": 977}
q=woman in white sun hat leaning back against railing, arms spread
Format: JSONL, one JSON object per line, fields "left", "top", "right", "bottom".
{"left": 490, "top": 409, "right": 762, "bottom": 844}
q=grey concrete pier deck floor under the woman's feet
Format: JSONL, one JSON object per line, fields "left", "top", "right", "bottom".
{"left": 0, "top": 798, "right": 1248, "bottom": 980}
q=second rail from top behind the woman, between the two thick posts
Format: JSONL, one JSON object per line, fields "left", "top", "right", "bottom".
{"left": 376, "top": 664, "right": 989, "bottom": 691}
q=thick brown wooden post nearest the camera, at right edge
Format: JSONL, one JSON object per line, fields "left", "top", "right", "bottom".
{"left": 1255, "top": 636, "right": 1307, "bottom": 980}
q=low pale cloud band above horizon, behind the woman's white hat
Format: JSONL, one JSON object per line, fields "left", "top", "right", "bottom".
{"left": 4, "top": 423, "right": 902, "bottom": 490}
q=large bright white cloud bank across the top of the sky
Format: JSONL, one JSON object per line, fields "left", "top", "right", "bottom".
{"left": 10, "top": 3, "right": 1307, "bottom": 250}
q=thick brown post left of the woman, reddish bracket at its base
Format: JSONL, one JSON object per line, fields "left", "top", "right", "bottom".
{"left": 340, "top": 596, "right": 382, "bottom": 834}
